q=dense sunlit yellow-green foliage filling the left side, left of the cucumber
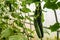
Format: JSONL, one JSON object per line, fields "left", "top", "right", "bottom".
{"left": 0, "top": 0, "right": 33, "bottom": 40}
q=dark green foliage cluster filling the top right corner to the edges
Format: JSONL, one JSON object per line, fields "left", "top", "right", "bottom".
{"left": 43, "top": 0, "right": 60, "bottom": 10}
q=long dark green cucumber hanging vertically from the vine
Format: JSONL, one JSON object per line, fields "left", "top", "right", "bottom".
{"left": 34, "top": 3, "right": 43, "bottom": 38}
